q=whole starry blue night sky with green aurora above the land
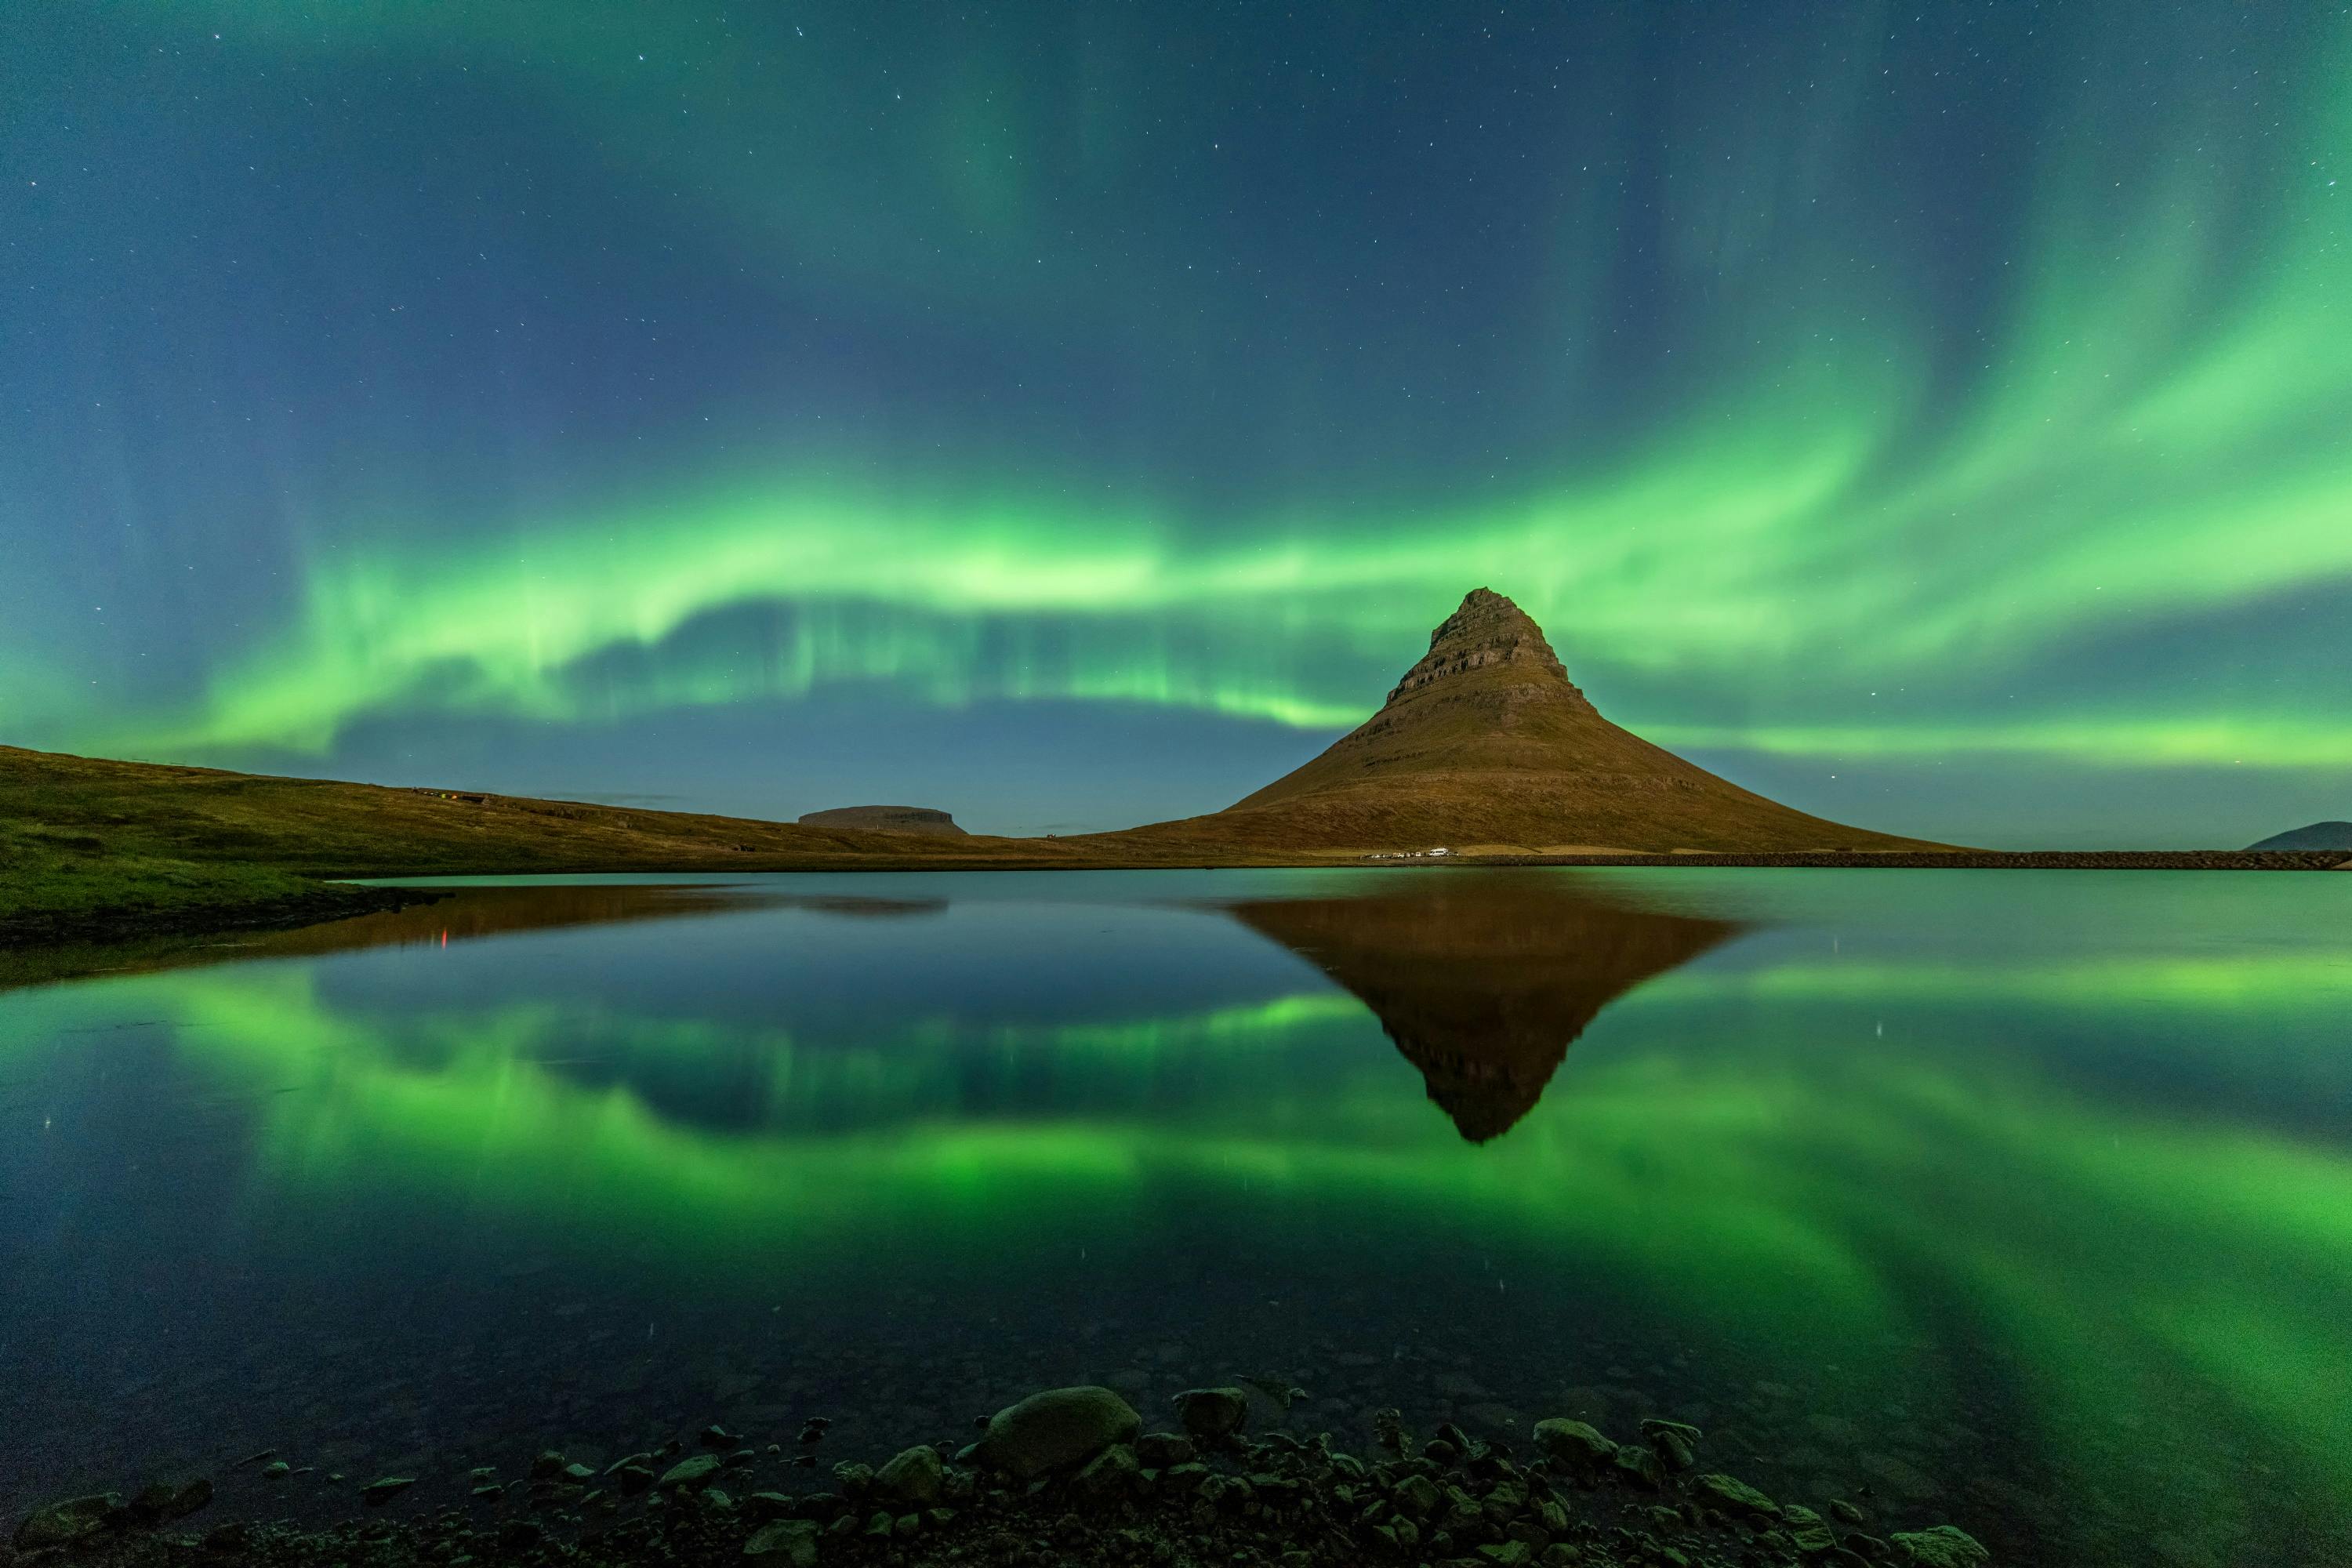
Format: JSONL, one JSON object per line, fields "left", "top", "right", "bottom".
{"left": 0, "top": 0, "right": 2352, "bottom": 846}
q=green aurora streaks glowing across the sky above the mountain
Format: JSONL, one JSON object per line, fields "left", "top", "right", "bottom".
{"left": 12, "top": 5, "right": 2352, "bottom": 785}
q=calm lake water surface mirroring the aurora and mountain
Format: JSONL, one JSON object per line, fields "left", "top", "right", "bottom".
{"left": 0, "top": 869, "right": 2352, "bottom": 1566}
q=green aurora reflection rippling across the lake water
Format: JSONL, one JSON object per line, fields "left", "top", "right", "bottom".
{"left": 0, "top": 872, "right": 2352, "bottom": 1559}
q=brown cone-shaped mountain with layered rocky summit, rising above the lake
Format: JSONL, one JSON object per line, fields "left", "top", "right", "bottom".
{"left": 1131, "top": 588, "right": 1931, "bottom": 853}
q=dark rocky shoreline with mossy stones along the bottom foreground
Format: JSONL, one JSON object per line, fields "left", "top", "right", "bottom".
{"left": 13, "top": 1385, "right": 1992, "bottom": 1568}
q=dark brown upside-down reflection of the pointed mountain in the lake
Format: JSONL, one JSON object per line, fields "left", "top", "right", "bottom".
{"left": 1232, "top": 872, "right": 1738, "bottom": 1142}
